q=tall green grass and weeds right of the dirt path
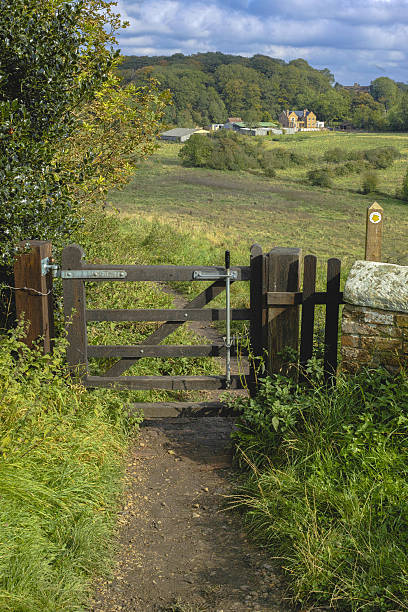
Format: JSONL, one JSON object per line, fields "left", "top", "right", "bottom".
{"left": 234, "top": 362, "right": 408, "bottom": 612}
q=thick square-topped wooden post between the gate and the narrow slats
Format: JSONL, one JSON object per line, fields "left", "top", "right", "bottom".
{"left": 267, "top": 247, "right": 302, "bottom": 374}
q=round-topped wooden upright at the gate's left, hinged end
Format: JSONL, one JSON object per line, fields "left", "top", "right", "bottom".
{"left": 62, "top": 244, "right": 88, "bottom": 377}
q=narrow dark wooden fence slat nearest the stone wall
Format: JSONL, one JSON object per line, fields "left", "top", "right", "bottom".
{"left": 324, "top": 258, "right": 341, "bottom": 380}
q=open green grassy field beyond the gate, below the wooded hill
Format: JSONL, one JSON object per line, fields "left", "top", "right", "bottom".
{"left": 110, "top": 133, "right": 408, "bottom": 284}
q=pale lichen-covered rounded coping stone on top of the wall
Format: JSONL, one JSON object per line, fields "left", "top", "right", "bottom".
{"left": 344, "top": 260, "right": 408, "bottom": 313}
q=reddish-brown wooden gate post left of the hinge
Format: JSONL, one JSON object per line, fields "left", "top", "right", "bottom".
{"left": 14, "top": 240, "right": 54, "bottom": 353}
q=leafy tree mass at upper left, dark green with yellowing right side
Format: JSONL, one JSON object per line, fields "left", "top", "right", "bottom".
{"left": 0, "top": 0, "right": 169, "bottom": 263}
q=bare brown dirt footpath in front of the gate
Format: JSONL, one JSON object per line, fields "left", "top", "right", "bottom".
{"left": 91, "top": 417, "right": 292, "bottom": 612}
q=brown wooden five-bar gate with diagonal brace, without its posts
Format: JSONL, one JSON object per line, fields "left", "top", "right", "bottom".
{"left": 62, "top": 245, "right": 251, "bottom": 390}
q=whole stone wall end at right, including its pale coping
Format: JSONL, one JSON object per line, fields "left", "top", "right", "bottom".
{"left": 342, "top": 261, "right": 408, "bottom": 371}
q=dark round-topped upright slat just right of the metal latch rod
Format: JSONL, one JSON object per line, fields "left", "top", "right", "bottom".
{"left": 249, "top": 244, "right": 268, "bottom": 395}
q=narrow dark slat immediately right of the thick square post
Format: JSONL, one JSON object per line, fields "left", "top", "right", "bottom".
{"left": 300, "top": 255, "right": 317, "bottom": 366}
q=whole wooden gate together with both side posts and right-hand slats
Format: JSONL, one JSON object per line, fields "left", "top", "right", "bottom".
{"left": 15, "top": 241, "right": 343, "bottom": 393}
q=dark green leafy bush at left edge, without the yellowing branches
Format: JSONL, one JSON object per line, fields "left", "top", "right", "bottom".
{"left": 0, "top": 0, "right": 115, "bottom": 264}
